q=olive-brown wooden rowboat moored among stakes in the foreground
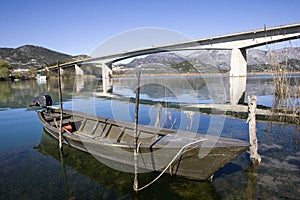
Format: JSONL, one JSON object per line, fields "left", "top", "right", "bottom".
{"left": 38, "top": 109, "right": 249, "bottom": 180}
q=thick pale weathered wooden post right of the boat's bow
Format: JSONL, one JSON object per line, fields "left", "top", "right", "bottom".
{"left": 247, "top": 96, "right": 261, "bottom": 166}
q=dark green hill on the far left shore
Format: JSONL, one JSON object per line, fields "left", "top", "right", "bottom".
{"left": 0, "top": 45, "right": 86, "bottom": 68}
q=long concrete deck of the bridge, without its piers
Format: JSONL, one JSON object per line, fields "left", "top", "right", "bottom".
{"left": 41, "top": 23, "right": 300, "bottom": 70}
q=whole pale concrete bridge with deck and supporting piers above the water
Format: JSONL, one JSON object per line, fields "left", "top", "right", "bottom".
{"left": 42, "top": 23, "right": 300, "bottom": 104}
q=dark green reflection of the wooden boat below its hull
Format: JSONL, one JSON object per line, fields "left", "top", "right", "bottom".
{"left": 35, "top": 131, "right": 221, "bottom": 200}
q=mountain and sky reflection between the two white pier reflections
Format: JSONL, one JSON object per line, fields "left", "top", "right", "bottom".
{"left": 113, "top": 76, "right": 229, "bottom": 103}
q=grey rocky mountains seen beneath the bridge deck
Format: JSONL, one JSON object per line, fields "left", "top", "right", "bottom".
{"left": 118, "top": 47, "right": 300, "bottom": 73}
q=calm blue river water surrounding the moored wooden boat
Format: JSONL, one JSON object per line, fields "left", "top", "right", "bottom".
{"left": 0, "top": 76, "right": 300, "bottom": 199}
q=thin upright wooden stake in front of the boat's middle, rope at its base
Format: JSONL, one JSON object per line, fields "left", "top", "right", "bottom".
{"left": 133, "top": 71, "right": 141, "bottom": 192}
